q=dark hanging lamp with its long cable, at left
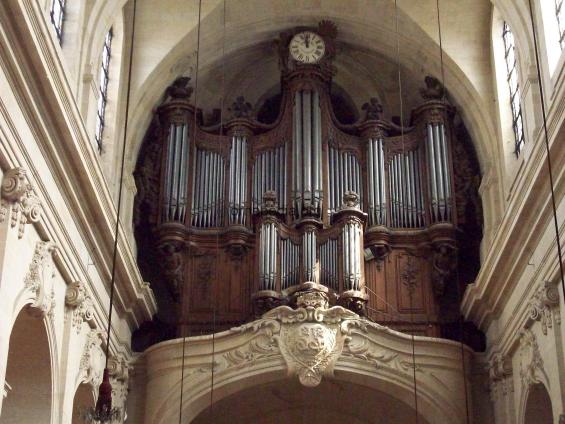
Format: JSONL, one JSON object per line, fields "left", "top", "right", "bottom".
{"left": 84, "top": 0, "right": 137, "bottom": 424}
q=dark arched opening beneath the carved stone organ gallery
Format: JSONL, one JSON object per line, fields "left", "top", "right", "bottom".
{"left": 192, "top": 380, "right": 428, "bottom": 424}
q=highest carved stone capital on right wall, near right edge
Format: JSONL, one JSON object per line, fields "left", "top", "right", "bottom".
{"left": 525, "top": 281, "right": 561, "bottom": 335}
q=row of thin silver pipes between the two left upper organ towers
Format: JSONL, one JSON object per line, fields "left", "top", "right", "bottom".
{"left": 192, "top": 149, "right": 225, "bottom": 227}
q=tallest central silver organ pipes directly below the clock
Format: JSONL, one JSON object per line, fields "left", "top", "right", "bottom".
{"left": 292, "top": 90, "right": 322, "bottom": 218}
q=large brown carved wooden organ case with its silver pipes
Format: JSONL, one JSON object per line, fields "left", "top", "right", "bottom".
{"left": 135, "top": 22, "right": 482, "bottom": 342}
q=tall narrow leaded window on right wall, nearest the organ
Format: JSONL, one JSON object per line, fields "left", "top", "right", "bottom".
{"left": 502, "top": 22, "right": 524, "bottom": 156}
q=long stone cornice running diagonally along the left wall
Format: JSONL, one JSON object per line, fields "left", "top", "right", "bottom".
{"left": 0, "top": 0, "right": 157, "bottom": 328}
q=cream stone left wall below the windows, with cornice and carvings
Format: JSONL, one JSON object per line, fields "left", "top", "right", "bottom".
{"left": 0, "top": 2, "right": 156, "bottom": 423}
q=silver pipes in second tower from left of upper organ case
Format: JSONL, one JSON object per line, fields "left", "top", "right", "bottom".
{"left": 228, "top": 136, "right": 247, "bottom": 225}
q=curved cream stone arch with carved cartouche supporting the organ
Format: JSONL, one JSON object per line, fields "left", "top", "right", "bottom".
{"left": 143, "top": 306, "right": 470, "bottom": 424}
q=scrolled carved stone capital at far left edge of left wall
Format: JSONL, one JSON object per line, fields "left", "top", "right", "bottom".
{"left": 0, "top": 167, "right": 42, "bottom": 238}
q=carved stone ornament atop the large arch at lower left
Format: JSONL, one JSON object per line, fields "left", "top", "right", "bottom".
{"left": 24, "top": 241, "right": 56, "bottom": 319}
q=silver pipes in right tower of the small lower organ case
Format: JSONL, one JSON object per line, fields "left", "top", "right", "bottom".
{"left": 342, "top": 221, "right": 362, "bottom": 290}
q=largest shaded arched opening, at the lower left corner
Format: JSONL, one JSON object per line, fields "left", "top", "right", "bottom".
{"left": 1, "top": 307, "right": 54, "bottom": 424}
